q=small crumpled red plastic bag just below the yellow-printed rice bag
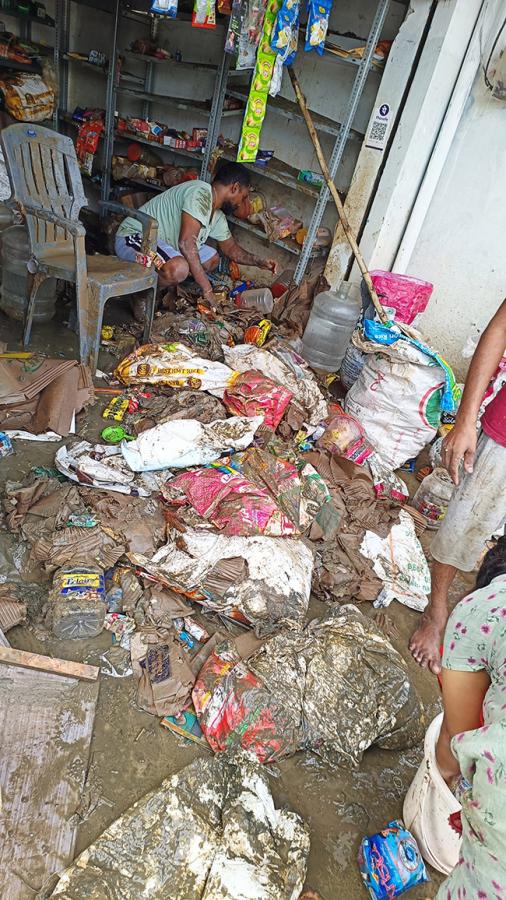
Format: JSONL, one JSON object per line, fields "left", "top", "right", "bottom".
{"left": 223, "top": 370, "right": 293, "bottom": 431}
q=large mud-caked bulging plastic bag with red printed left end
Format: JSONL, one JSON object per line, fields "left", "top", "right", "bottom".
{"left": 192, "top": 605, "right": 423, "bottom": 766}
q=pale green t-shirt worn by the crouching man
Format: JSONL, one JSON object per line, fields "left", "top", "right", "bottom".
{"left": 117, "top": 181, "right": 231, "bottom": 250}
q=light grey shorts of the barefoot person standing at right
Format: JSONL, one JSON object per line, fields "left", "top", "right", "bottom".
{"left": 430, "top": 432, "right": 506, "bottom": 572}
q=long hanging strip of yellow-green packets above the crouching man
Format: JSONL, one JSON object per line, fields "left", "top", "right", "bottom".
{"left": 237, "top": 0, "right": 281, "bottom": 162}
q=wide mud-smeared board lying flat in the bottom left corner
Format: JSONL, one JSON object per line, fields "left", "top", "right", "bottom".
{"left": 0, "top": 666, "right": 98, "bottom": 900}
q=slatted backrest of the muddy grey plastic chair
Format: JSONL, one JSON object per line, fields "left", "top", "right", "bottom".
{"left": 1, "top": 123, "right": 87, "bottom": 256}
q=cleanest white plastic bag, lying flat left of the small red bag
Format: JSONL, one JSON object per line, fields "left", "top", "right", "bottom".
{"left": 121, "top": 416, "right": 263, "bottom": 472}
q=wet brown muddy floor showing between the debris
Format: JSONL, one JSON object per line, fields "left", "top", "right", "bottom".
{"left": 0, "top": 304, "right": 469, "bottom": 900}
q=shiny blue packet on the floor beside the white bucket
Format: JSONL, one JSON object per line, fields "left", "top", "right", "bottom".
{"left": 358, "top": 820, "right": 429, "bottom": 900}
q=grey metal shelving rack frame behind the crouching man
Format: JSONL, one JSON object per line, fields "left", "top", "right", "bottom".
{"left": 55, "top": 0, "right": 391, "bottom": 283}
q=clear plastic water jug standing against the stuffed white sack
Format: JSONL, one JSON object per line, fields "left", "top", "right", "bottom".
{"left": 302, "top": 282, "right": 362, "bottom": 372}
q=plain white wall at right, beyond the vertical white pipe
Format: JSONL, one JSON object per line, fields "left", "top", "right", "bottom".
{"left": 407, "top": 72, "right": 506, "bottom": 374}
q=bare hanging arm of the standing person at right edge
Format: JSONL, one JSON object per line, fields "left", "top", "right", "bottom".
{"left": 442, "top": 300, "right": 506, "bottom": 484}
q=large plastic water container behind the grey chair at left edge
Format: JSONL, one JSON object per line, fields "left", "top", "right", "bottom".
{"left": 0, "top": 225, "right": 56, "bottom": 322}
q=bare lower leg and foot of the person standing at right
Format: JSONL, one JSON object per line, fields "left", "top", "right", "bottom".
{"left": 409, "top": 559, "right": 457, "bottom": 675}
